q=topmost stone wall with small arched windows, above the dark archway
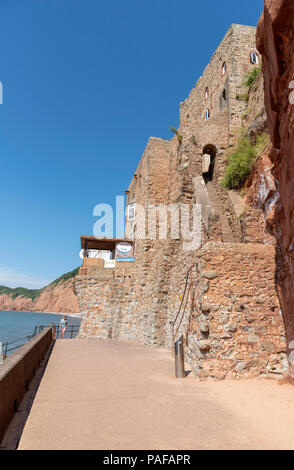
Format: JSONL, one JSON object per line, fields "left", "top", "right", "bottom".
{"left": 179, "top": 25, "right": 256, "bottom": 184}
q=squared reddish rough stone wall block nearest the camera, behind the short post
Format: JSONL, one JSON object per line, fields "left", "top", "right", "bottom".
{"left": 187, "top": 242, "right": 288, "bottom": 379}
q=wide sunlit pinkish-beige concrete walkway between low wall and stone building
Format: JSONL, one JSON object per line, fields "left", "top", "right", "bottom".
{"left": 19, "top": 340, "right": 294, "bottom": 450}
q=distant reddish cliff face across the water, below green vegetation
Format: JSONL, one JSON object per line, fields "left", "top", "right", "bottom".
{"left": 0, "top": 277, "right": 80, "bottom": 313}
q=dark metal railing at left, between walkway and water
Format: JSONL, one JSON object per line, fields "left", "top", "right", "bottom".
{"left": 0, "top": 323, "right": 80, "bottom": 362}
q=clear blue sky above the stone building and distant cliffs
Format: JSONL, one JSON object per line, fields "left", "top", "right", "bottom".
{"left": 0, "top": 0, "right": 263, "bottom": 288}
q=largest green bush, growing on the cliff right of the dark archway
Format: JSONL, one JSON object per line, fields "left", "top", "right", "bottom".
{"left": 221, "top": 134, "right": 268, "bottom": 189}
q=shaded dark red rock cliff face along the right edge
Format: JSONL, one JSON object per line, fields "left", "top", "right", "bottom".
{"left": 257, "top": 0, "right": 294, "bottom": 376}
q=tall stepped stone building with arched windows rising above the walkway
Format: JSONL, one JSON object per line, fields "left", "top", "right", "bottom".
{"left": 75, "top": 25, "right": 288, "bottom": 379}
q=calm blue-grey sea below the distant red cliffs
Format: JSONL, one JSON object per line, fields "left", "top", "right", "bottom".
{"left": 0, "top": 311, "right": 81, "bottom": 354}
